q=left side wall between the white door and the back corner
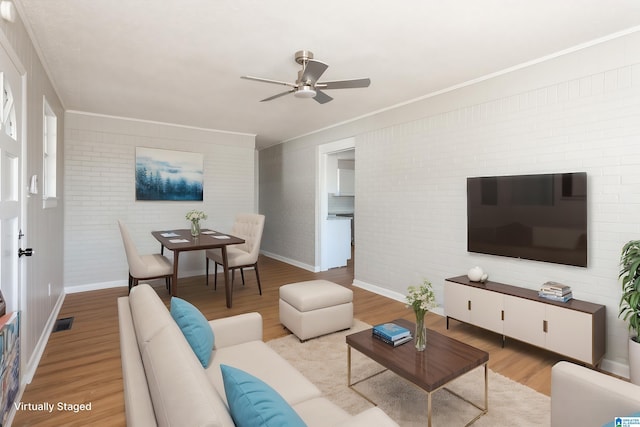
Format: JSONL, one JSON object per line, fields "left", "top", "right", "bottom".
{"left": 0, "top": 6, "right": 64, "bottom": 381}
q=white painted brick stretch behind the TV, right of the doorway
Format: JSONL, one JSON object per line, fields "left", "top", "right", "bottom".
{"left": 355, "top": 64, "right": 640, "bottom": 372}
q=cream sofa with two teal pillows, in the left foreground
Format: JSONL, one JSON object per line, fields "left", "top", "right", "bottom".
{"left": 118, "top": 284, "right": 397, "bottom": 427}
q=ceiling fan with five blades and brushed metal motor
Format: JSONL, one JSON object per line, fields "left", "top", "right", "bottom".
{"left": 241, "top": 50, "right": 371, "bottom": 104}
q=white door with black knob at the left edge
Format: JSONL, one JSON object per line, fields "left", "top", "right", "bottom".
{"left": 0, "top": 46, "right": 23, "bottom": 311}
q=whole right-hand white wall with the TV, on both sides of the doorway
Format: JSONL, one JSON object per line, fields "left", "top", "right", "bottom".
{"left": 260, "top": 33, "right": 640, "bottom": 372}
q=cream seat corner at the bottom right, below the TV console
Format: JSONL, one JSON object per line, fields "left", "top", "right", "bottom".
{"left": 551, "top": 362, "right": 640, "bottom": 427}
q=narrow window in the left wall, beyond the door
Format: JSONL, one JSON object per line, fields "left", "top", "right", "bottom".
{"left": 42, "top": 99, "right": 58, "bottom": 208}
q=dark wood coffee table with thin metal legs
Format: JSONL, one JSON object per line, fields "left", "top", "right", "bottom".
{"left": 347, "top": 319, "right": 489, "bottom": 427}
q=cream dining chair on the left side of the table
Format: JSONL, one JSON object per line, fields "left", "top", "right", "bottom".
{"left": 118, "top": 220, "right": 173, "bottom": 290}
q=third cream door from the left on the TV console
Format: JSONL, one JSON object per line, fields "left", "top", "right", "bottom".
{"left": 504, "top": 295, "right": 546, "bottom": 347}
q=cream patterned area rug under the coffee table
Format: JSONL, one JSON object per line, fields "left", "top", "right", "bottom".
{"left": 267, "top": 320, "right": 550, "bottom": 427}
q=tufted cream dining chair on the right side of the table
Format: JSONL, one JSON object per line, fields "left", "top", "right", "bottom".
{"left": 206, "top": 214, "right": 264, "bottom": 295}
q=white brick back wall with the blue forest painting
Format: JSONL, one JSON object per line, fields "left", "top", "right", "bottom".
{"left": 64, "top": 112, "right": 257, "bottom": 292}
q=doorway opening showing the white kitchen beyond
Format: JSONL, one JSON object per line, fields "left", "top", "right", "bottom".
{"left": 316, "top": 138, "right": 355, "bottom": 271}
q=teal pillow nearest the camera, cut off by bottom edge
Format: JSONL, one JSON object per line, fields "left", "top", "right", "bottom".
{"left": 220, "top": 365, "right": 306, "bottom": 427}
